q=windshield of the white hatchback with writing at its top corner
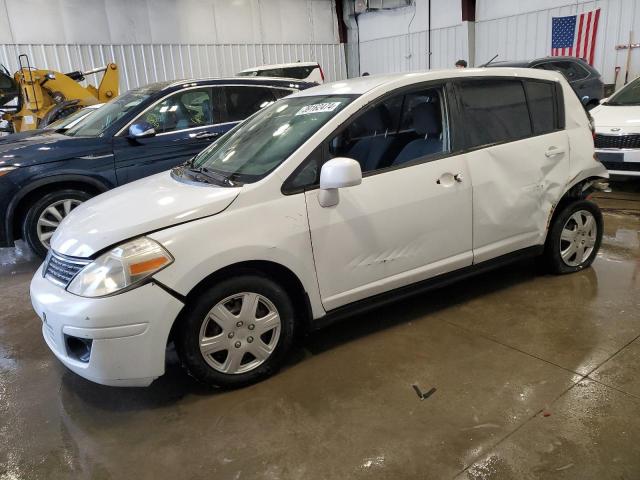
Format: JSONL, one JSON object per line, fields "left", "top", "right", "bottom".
{"left": 188, "top": 95, "right": 356, "bottom": 183}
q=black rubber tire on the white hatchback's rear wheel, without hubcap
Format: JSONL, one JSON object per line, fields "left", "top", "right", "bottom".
{"left": 544, "top": 200, "right": 604, "bottom": 275}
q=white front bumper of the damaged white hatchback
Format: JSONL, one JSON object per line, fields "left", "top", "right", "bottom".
{"left": 31, "top": 267, "right": 183, "bottom": 386}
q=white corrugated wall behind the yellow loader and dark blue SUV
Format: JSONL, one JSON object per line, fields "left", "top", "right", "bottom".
{"left": 0, "top": 43, "right": 347, "bottom": 92}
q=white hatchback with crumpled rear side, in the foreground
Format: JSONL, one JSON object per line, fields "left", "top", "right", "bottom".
{"left": 31, "top": 68, "right": 607, "bottom": 386}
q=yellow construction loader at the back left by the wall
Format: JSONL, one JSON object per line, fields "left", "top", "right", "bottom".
{"left": 0, "top": 54, "right": 118, "bottom": 132}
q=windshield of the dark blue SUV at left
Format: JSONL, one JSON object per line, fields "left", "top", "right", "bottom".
{"left": 64, "top": 87, "right": 158, "bottom": 137}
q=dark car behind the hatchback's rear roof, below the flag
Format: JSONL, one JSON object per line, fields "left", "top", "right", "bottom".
{"left": 487, "top": 57, "right": 604, "bottom": 109}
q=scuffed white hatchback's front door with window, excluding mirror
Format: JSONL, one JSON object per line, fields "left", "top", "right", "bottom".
{"left": 301, "top": 85, "right": 472, "bottom": 310}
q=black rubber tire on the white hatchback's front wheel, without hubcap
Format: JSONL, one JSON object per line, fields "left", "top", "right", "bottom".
{"left": 175, "top": 274, "right": 296, "bottom": 388}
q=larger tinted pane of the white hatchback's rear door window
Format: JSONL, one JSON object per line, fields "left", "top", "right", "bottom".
{"left": 458, "top": 79, "right": 532, "bottom": 148}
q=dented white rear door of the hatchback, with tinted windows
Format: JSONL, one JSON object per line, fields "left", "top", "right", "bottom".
{"left": 456, "top": 78, "right": 569, "bottom": 263}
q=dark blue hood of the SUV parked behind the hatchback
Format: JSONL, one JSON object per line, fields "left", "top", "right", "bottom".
{"left": 0, "top": 131, "right": 101, "bottom": 167}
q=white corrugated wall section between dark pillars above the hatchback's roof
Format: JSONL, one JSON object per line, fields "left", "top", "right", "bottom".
{"left": 360, "top": 24, "right": 468, "bottom": 74}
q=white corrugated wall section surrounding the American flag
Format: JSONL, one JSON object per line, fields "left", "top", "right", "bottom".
{"left": 475, "top": 0, "right": 640, "bottom": 83}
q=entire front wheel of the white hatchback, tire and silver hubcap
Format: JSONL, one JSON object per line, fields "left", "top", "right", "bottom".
{"left": 176, "top": 275, "right": 294, "bottom": 387}
